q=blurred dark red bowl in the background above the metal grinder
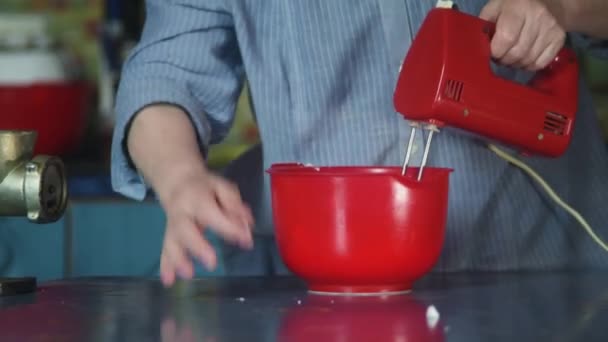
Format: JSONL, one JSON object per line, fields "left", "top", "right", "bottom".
{"left": 0, "top": 81, "right": 90, "bottom": 156}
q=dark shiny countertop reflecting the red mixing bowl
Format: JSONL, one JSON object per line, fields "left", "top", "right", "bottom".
{"left": 0, "top": 273, "right": 608, "bottom": 342}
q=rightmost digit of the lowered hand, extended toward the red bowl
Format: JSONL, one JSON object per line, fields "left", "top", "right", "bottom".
{"left": 197, "top": 205, "right": 253, "bottom": 248}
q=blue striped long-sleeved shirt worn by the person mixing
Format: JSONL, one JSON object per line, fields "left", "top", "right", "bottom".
{"left": 112, "top": 0, "right": 608, "bottom": 271}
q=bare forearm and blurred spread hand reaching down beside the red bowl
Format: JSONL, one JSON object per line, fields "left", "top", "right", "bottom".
{"left": 128, "top": 105, "right": 253, "bottom": 286}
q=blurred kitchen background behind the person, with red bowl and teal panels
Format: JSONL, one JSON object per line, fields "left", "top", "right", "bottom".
{"left": 0, "top": 0, "right": 608, "bottom": 280}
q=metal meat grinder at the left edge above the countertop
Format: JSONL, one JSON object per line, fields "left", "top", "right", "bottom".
{"left": 0, "top": 130, "right": 68, "bottom": 296}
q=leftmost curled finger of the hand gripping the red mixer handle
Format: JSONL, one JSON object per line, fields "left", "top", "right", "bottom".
{"left": 491, "top": 12, "right": 525, "bottom": 60}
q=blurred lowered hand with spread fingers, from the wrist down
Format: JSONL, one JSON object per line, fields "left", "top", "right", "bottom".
{"left": 160, "top": 171, "right": 253, "bottom": 286}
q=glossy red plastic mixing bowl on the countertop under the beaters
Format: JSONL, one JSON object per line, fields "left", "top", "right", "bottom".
{"left": 267, "top": 164, "right": 452, "bottom": 293}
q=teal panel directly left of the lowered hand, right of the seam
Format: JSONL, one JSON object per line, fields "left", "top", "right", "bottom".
{"left": 71, "top": 201, "right": 223, "bottom": 276}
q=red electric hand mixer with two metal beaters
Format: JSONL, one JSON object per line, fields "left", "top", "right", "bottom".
{"left": 394, "top": 1, "right": 578, "bottom": 180}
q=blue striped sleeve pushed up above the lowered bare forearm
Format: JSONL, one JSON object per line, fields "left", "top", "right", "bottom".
{"left": 111, "top": 0, "right": 243, "bottom": 200}
